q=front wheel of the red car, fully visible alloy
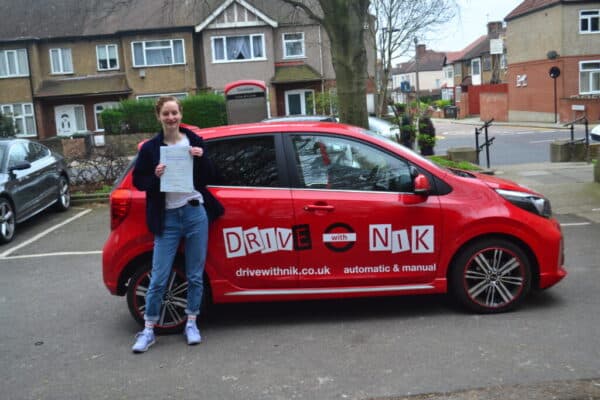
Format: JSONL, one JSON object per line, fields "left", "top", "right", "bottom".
{"left": 450, "top": 239, "right": 531, "bottom": 313}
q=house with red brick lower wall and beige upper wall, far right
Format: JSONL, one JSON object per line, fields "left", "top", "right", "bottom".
{"left": 505, "top": 0, "right": 600, "bottom": 122}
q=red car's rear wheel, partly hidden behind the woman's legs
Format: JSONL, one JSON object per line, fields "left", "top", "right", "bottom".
{"left": 127, "top": 263, "right": 211, "bottom": 334}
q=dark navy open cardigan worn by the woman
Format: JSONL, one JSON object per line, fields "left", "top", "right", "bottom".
{"left": 133, "top": 127, "right": 224, "bottom": 235}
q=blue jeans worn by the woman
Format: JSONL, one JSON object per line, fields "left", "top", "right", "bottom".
{"left": 144, "top": 204, "right": 208, "bottom": 322}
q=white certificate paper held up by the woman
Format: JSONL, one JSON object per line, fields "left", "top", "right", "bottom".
{"left": 160, "top": 146, "right": 194, "bottom": 193}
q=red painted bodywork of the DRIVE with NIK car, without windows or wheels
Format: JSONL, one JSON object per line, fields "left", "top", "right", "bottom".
{"left": 103, "top": 122, "right": 566, "bottom": 303}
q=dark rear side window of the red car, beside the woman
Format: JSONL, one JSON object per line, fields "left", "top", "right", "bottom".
{"left": 207, "top": 136, "right": 280, "bottom": 187}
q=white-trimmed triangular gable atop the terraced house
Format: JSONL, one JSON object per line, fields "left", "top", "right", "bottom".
{"left": 195, "top": 0, "right": 278, "bottom": 32}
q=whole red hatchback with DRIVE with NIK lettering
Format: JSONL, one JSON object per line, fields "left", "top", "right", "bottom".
{"left": 103, "top": 122, "right": 566, "bottom": 332}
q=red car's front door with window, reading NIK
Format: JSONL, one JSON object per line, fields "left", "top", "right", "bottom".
{"left": 288, "top": 133, "right": 443, "bottom": 288}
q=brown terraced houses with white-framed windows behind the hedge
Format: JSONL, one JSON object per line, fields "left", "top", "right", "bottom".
{"left": 0, "top": 0, "right": 375, "bottom": 139}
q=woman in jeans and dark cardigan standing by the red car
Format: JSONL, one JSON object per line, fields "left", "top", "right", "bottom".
{"left": 132, "top": 96, "right": 223, "bottom": 353}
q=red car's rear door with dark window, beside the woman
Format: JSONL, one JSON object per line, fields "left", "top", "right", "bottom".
{"left": 207, "top": 134, "right": 298, "bottom": 295}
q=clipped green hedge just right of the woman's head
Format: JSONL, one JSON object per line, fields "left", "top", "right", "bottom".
{"left": 181, "top": 93, "right": 227, "bottom": 128}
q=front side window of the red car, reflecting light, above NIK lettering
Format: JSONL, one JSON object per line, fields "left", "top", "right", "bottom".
{"left": 292, "top": 135, "right": 413, "bottom": 192}
